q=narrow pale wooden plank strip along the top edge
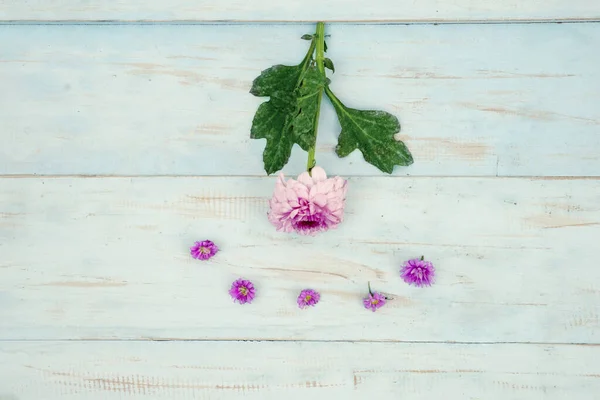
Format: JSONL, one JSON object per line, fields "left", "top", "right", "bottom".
{"left": 0, "top": 0, "right": 600, "bottom": 22}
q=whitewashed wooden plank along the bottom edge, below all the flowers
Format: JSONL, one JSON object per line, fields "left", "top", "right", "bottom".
{"left": 0, "top": 342, "right": 600, "bottom": 400}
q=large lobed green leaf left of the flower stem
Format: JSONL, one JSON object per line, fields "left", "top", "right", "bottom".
{"left": 250, "top": 59, "right": 325, "bottom": 174}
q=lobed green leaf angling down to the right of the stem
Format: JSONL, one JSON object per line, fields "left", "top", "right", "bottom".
{"left": 325, "top": 88, "right": 413, "bottom": 174}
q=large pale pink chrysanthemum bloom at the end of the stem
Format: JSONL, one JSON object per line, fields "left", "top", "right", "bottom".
{"left": 269, "top": 167, "right": 347, "bottom": 235}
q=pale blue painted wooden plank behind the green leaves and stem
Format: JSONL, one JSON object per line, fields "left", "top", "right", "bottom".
{"left": 0, "top": 23, "right": 600, "bottom": 176}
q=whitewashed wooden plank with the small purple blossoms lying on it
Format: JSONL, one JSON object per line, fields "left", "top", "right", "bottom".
{"left": 0, "top": 177, "right": 600, "bottom": 343}
